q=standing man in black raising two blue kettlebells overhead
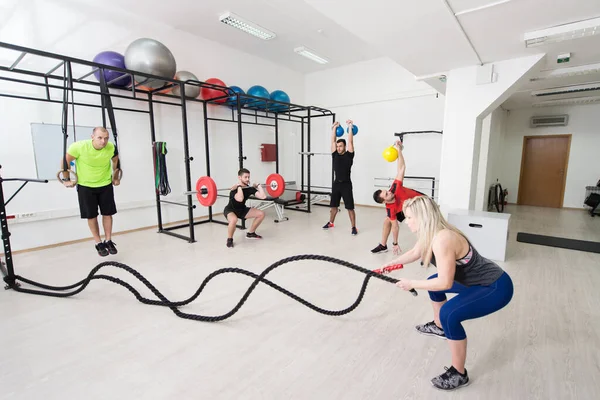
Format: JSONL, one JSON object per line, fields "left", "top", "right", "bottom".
{"left": 323, "top": 120, "right": 358, "bottom": 235}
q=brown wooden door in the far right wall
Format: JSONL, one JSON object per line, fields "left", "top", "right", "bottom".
{"left": 517, "top": 135, "right": 571, "bottom": 208}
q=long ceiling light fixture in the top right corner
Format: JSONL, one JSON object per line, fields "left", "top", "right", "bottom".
{"left": 524, "top": 18, "right": 600, "bottom": 47}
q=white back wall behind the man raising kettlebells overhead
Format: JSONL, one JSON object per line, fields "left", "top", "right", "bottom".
{"left": 306, "top": 58, "right": 444, "bottom": 205}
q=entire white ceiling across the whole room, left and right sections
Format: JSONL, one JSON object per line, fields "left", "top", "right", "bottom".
{"left": 0, "top": 0, "right": 600, "bottom": 109}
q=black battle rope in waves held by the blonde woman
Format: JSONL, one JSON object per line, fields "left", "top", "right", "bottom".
{"left": 13, "top": 254, "right": 417, "bottom": 322}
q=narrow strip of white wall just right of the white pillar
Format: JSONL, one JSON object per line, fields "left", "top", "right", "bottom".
{"left": 475, "top": 107, "right": 506, "bottom": 211}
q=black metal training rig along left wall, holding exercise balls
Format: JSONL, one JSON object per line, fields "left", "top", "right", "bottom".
{"left": 0, "top": 42, "right": 335, "bottom": 243}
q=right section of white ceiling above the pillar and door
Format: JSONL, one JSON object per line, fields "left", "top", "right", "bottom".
{"left": 305, "top": 0, "right": 600, "bottom": 109}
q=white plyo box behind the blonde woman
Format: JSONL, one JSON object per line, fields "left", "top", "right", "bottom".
{"left": 447, "top": 210, "right": 510, "bottom": 261}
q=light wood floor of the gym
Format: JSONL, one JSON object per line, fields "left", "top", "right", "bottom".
{"left": 0, "top": 206, "right": 600, "bottom": 400}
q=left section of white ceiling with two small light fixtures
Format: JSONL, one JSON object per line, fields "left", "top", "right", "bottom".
{"left": 0, "top": 0, "right": 380, "bottom": 73}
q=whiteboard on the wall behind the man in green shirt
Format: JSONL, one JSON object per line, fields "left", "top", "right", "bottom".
{"left": 31, "top": 123, "right": 114, "bottom": 180}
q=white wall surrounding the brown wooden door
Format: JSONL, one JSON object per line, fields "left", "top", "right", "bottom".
{"left": 498, "top": 104, "right": 600, "bottom": 208}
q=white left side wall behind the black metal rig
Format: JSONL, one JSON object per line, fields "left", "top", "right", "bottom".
{"left": 0, "top": 1, "right": 304, "bottom": 250}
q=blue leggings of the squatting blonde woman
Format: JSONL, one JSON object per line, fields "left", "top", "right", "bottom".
{"left": 428, "top": 272, "right": 513, "bottom": 340}
